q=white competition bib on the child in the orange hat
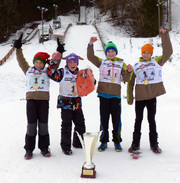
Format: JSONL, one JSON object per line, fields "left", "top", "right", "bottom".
{"left": 134, "top": 59, "right": 162, "bottom": 85}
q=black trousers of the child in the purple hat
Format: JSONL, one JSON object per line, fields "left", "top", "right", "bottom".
{"left": 60, "top": 109, "right": 86, "bottom": 150}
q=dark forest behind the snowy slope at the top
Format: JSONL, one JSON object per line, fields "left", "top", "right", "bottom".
{"left": 0, "top": 0, "right": 167, "bottom": 42}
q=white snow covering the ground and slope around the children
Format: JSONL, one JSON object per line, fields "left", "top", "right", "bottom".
{"left": 0, "top": 0, "right": 180, "bottom": 183}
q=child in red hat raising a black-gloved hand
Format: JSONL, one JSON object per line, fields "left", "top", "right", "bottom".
{"left": 13, "top": 34, "right": 51, "bottom": 159}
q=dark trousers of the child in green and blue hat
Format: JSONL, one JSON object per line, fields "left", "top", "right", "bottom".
{"left": 99, "top": 97, "right": 122, "bottom": 143}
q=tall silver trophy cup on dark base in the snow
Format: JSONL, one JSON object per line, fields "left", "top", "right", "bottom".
{"left": 77, "top": 132, "right": 101, "bottom": 178}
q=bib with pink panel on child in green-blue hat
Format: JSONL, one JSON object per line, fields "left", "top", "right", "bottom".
{"left": 99, "top": 59, "right": 123, "bottom": 85}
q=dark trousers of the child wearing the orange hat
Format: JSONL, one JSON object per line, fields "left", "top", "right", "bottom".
{"left": 133, "top": 98, "right": 157, "bottom": 146}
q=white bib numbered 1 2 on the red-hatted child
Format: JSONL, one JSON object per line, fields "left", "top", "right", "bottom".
{"left": 26, "top": 67, "right": 49, "bottom": 92}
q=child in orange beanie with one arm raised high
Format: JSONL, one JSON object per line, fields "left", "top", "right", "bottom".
{"left": 127, "top": 29, "right": 172, "bottom": 153}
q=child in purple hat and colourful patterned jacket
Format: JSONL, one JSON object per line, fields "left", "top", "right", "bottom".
{"left": 48, "top": 53, "right": 85, "bottom": 155}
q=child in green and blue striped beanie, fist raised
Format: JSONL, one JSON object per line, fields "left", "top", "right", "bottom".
{"left": 87, "top": 37, "right": 132, "bottom": 152}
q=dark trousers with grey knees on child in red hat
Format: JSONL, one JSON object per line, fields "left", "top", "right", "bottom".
{"left": 24, "top": 100, "right": 50, "bottom": 151}
